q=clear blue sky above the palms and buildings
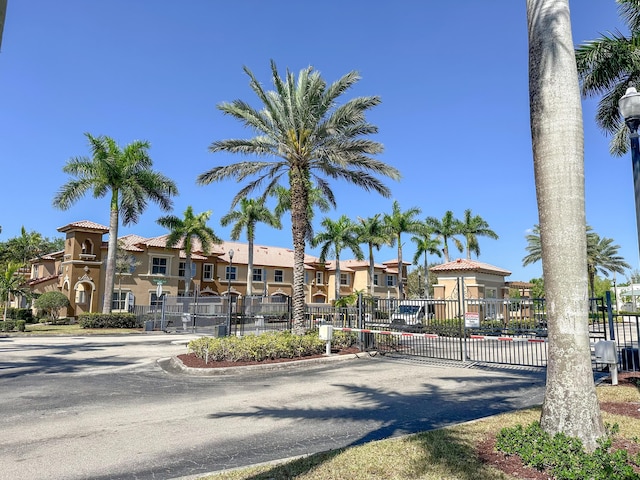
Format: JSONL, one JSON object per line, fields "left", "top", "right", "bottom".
{"left": 0, "top": 0, "right": 638, "bottom": 280}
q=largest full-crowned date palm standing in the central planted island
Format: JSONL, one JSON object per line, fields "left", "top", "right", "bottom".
{"left": 198, "top": 61, "right": 400, "bottom": 334}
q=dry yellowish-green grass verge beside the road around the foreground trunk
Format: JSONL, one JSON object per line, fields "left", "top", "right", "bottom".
{"left": 202, "top": 387, "right": 640, "bottom": 480}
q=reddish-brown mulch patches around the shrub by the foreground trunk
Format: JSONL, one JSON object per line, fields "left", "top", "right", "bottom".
{"left": 476, "top": 372, "right": 640, "bottom": 480}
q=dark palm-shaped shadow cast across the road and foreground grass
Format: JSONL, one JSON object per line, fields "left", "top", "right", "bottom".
{"left": 209, "top": 372, "right": 544, "bottom": 480}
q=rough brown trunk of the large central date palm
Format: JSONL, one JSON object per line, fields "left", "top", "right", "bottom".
{"left": 289, "top": 169, "right": 309, "bottom": 335}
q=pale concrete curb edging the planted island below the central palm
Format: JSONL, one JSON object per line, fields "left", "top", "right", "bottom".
{"left": 157, "top": 352, "right": 375, "bottom": 377}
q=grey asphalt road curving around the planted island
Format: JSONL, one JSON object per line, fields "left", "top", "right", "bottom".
{"left": 0, "top": 335, "right": 544, "bottom": 480}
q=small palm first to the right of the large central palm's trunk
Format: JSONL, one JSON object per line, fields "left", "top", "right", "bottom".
{"left": 311, "top": 215, "right": 364, "bottom": 300}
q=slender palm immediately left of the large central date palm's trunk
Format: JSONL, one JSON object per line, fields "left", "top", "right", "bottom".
{"left": 220, "top": 198, "right": 282, "bottom": 297}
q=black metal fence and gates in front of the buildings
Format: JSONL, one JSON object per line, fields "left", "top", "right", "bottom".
{"left": 136, "top": 290, "right": 640, "bottom": 370}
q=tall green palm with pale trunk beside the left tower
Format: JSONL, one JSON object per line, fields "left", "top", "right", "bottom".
{"left": 53, "top": 133, "right": 178, "bottom": 313}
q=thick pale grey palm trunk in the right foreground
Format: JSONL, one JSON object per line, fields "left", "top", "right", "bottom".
{"left": 527, "top": 0, "right": 605, "bottom": 450}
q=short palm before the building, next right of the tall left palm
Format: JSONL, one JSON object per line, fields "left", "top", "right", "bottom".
{"left": 157, "top": 205, "right": 222, "bottom": 296}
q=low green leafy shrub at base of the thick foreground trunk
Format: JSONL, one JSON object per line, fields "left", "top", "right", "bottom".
{"left": 496, "top": 422, "right": 640, "bottom": 480}
